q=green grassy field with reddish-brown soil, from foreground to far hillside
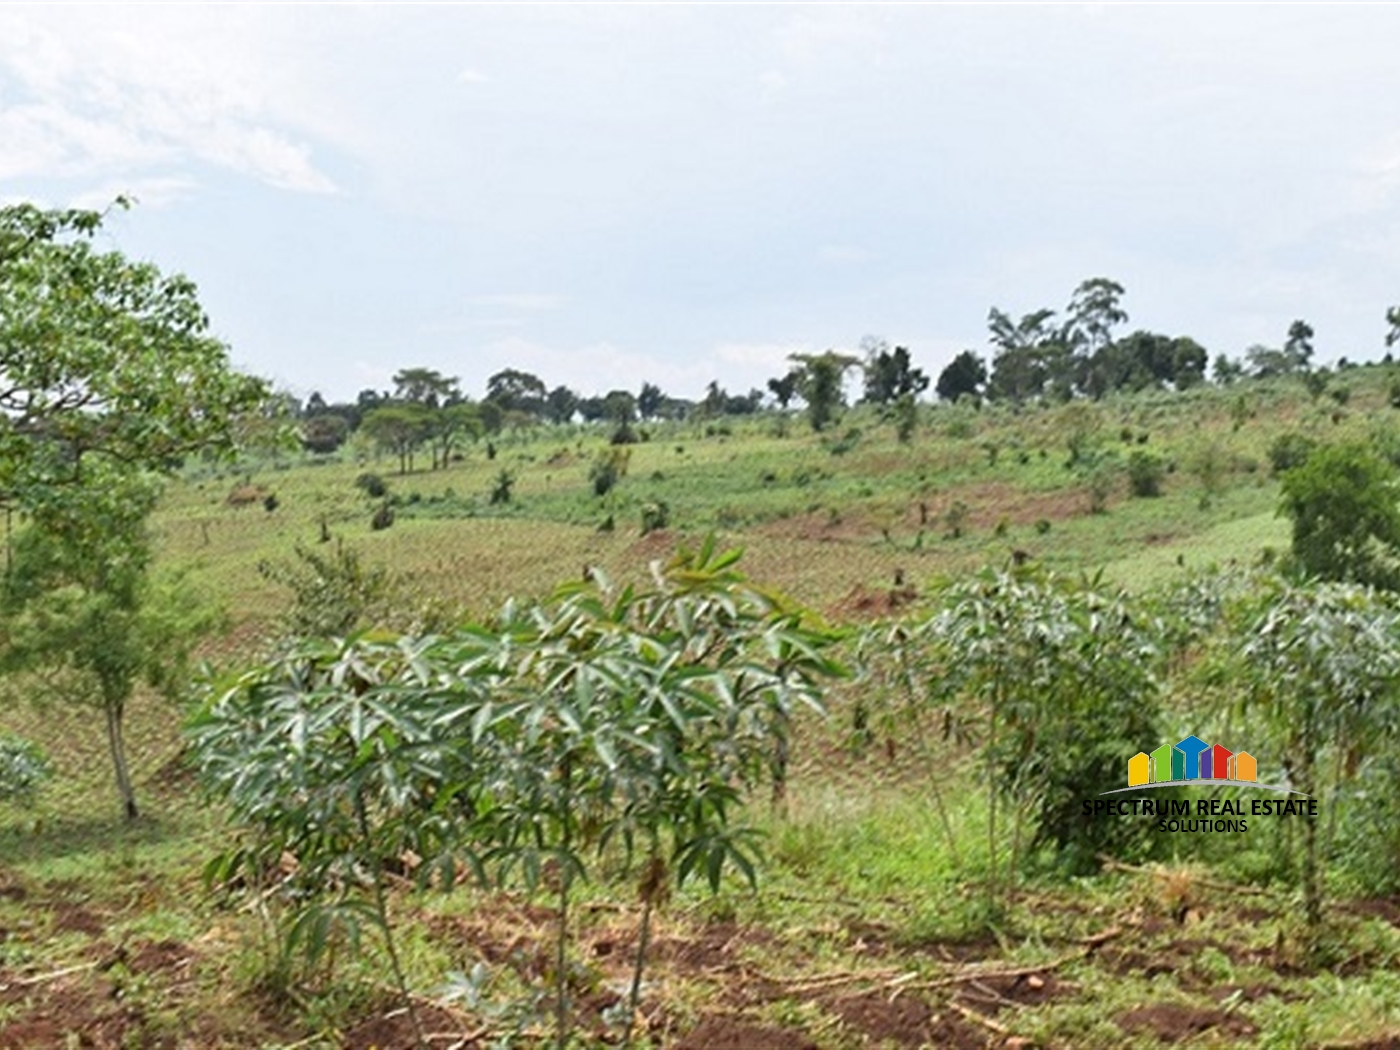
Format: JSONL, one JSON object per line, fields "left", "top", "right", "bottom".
{"left": 0, "top": 365, "right": 1400, "bottom": 1050}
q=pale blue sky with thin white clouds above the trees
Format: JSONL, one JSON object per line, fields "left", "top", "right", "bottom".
{"left": 0, "top": 4, "right": 1400, "bottom": 400}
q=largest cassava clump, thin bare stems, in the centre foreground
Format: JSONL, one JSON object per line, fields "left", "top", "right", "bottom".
{"left": 192, "top": 540, "right": 841, "bottom": 1047}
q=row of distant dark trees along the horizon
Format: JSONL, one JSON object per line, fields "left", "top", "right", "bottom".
{"left": 289, "top": 277, "right": 1400, "bottom": 472}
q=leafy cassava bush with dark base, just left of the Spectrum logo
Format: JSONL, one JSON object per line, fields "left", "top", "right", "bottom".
{"left": 921, "top": 571, "right": 1162, "bottom": 889}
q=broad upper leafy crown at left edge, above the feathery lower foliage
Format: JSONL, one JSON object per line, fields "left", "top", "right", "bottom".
{"left": 0, "top": 202, "right": 267, "bottom": 495}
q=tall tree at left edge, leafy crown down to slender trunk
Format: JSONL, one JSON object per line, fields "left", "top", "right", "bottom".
{"left": 0, "top": 200, "right": 267, "bottom": 818}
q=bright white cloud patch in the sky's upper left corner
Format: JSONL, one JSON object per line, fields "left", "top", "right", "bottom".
{"left": 0, "top": 8, "right": 335, "bottom": 193}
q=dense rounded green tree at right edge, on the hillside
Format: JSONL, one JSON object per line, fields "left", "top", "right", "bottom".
{"left": 1281, "top": 444, "right": 1400, "bottom": 591}
